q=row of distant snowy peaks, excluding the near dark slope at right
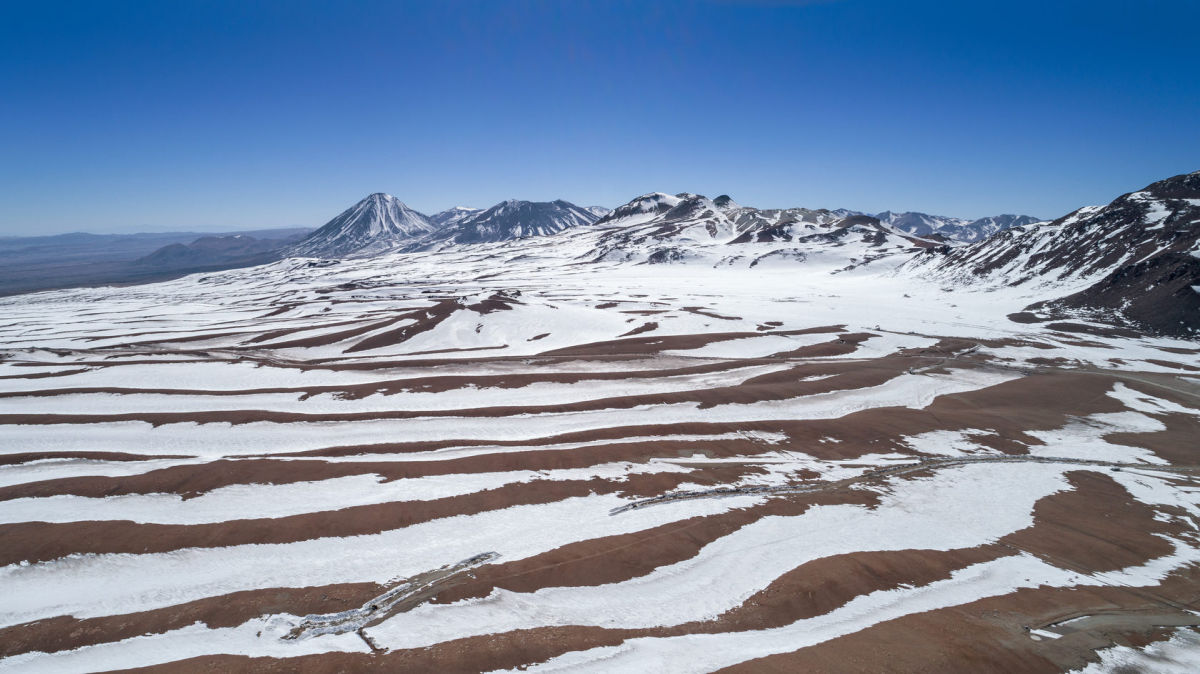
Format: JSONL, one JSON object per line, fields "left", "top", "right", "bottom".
{"left": 284, "top": 192, "right": 1033, "bottom": 264}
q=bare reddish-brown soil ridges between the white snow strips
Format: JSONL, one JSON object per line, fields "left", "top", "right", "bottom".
{"left": 0, "top": 338, "right": 1200, "bottom": 672}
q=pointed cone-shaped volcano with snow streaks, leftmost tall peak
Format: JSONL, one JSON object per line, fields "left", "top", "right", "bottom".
{"left": 287, "top": 192, "right": 437, "bottom": 258}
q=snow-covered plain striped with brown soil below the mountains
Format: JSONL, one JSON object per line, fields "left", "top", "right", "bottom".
{"left": 0, "top": 208, "right": 1200, "bottom": 672}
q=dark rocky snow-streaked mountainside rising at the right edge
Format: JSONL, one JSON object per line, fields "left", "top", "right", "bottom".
{"left": 906, "top": 171, "right": 1200, "bottom": 336}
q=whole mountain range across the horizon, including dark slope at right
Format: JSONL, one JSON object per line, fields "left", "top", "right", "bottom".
{"left": 0, "top": 173, "right": 1200, "bottom": 336}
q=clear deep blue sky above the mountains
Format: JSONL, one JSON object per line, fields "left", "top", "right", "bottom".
{"left": 0, "top": 0, "right": 1200, "bottom": 235}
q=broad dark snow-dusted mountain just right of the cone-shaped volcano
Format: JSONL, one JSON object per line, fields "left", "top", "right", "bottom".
{"left": 406, "top": 199, "right": 599, "bottom": 251}
